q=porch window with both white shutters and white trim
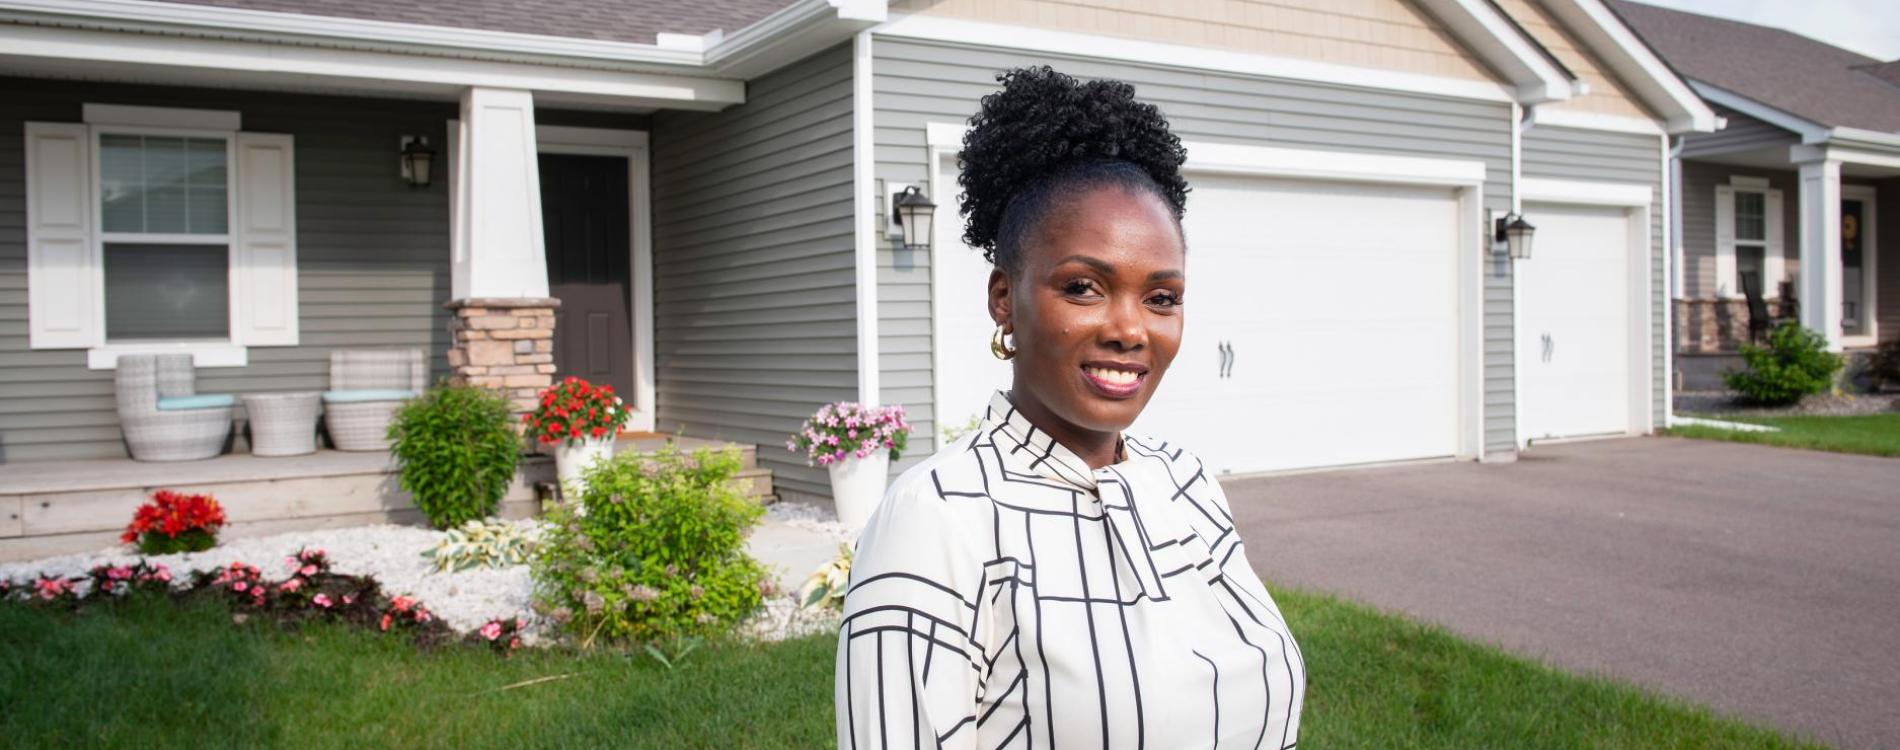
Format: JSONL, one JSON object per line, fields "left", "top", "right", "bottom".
{"left": 27, "top": 104, "right": 298, "bottom": 368}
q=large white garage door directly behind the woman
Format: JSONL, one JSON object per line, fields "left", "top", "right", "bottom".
{"left": 935, "top": 169, "right": 1476, "bottom": 473}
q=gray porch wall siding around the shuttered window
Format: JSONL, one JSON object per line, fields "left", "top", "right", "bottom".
{"left": 0, "top": 78, "right": 456, "bottom": 463}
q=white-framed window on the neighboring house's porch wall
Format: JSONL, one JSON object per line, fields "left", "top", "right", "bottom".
{"left": 1716, "top": 177, "right": 1786, "bottom": 298}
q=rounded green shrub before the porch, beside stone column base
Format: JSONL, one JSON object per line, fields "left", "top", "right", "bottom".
{"left": 390, "top": 385, "right": 521, "bottom": 528}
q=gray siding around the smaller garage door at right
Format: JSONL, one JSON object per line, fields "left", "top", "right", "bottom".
{"left": 1524, "top": 125, "right": 1670, "bottom": 425}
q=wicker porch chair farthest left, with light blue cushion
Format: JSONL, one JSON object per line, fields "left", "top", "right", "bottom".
{"left": 112, "top": 353, "right": 238, "bottom": 461}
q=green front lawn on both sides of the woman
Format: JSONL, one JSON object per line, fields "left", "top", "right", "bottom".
{"left": 0, "top": 592, "right": 1799, "bottom": 748}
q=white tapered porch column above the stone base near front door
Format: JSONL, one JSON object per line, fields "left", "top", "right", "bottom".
{"left": 450, "top": 87, "right": 547, "bottom": 300}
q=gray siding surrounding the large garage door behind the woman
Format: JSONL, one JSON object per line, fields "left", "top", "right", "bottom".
{"left": 872, "top": 36, "right": 1516, "bottom": 463}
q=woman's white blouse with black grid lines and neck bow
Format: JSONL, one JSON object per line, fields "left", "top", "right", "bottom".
{"left": 836, "top": 393, "right": 1305, "bottom": 750}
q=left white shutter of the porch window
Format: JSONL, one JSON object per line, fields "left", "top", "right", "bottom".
{"left": 27, "top": 122, "right": 105, "bottom": 349}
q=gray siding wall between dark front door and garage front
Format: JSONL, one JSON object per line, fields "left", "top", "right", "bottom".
{"left": 652, "top": 46, "right": 857, "bottom": 496}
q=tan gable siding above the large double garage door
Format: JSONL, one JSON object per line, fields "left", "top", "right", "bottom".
{"left": 891, "top": 0, "right": 1495, "bottom": 82}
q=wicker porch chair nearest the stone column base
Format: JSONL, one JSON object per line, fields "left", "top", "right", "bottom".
{"left": 323, "top": 349, "right": 429, "bottom": 450}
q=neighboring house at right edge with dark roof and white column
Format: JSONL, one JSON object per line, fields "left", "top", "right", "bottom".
{"left": 1615, "top": 0, "right": 1900, "bottom": 389}
